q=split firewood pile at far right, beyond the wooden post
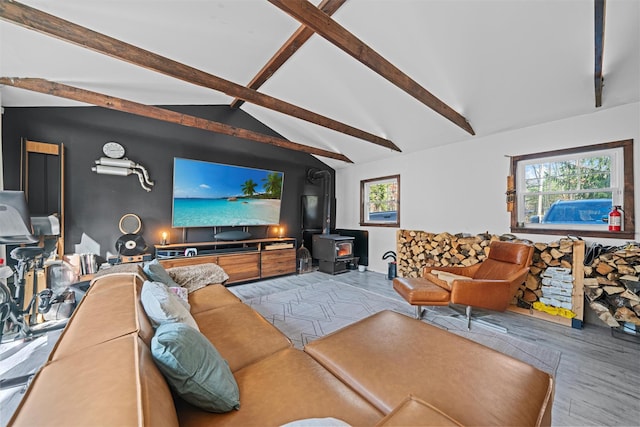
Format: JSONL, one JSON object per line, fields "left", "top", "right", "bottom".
{"left": 584, "top": 246, "right": 640, "bottom": 330}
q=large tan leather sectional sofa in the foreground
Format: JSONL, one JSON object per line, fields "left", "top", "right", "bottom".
{"left": 10, "top": 270, "right": 553, "bottom": 427}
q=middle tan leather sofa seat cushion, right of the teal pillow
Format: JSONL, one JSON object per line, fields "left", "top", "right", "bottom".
{"left": 193, "top": 304, "right": 292, "bottom": 372}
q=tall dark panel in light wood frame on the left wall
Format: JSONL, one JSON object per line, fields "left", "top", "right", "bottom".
{"left": 20, "top": 139, "right": 64, "bottom": 256}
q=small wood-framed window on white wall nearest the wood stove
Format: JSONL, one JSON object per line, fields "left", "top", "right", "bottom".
{"left": 360, "top": 175, "right": 400, "bottom": 227}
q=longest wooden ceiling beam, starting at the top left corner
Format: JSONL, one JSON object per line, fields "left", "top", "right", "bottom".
{"left": 0, "top": 0, "right": 401, "bottom": 151}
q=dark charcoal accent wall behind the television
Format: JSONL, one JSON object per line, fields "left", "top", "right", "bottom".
{"left": 2, "top": 106, "right": 335, "bottom": 256}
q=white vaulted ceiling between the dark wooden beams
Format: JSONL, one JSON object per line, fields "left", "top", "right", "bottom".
{"left": 0, "top": 0, "right": 640, "bottom": 168}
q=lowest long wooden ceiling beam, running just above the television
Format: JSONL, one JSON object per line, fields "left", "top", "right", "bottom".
{"left": 0, "top": 77, "right": 353, "bottom": 163}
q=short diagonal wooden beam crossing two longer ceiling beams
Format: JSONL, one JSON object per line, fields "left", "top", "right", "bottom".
{"left": 231, "top": 0, "right": 347, "bottom": 108}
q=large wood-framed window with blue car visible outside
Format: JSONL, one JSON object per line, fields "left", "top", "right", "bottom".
{"left": 511, "top": 140, "right": 635, "bottom": 238}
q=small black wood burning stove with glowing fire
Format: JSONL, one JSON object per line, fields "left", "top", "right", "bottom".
{"left": 313, "top": 234, "right": 354, "bottom": 274}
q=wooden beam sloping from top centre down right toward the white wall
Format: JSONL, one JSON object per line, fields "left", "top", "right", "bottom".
{"left": 269, "top": 0, "right": 475, "bottom": 135}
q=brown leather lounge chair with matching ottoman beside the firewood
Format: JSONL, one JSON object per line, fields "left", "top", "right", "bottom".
{"left": 393, "top": 241, "right": 533, "bottom": 328}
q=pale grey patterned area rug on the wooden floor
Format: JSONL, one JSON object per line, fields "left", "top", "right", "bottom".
{"left": 245, "top": 279, "right": 560, "bottom": 375}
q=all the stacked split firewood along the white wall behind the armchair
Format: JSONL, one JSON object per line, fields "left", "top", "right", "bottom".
{"left": 397, "top": 230, "right": 640, "bottom": 330}
